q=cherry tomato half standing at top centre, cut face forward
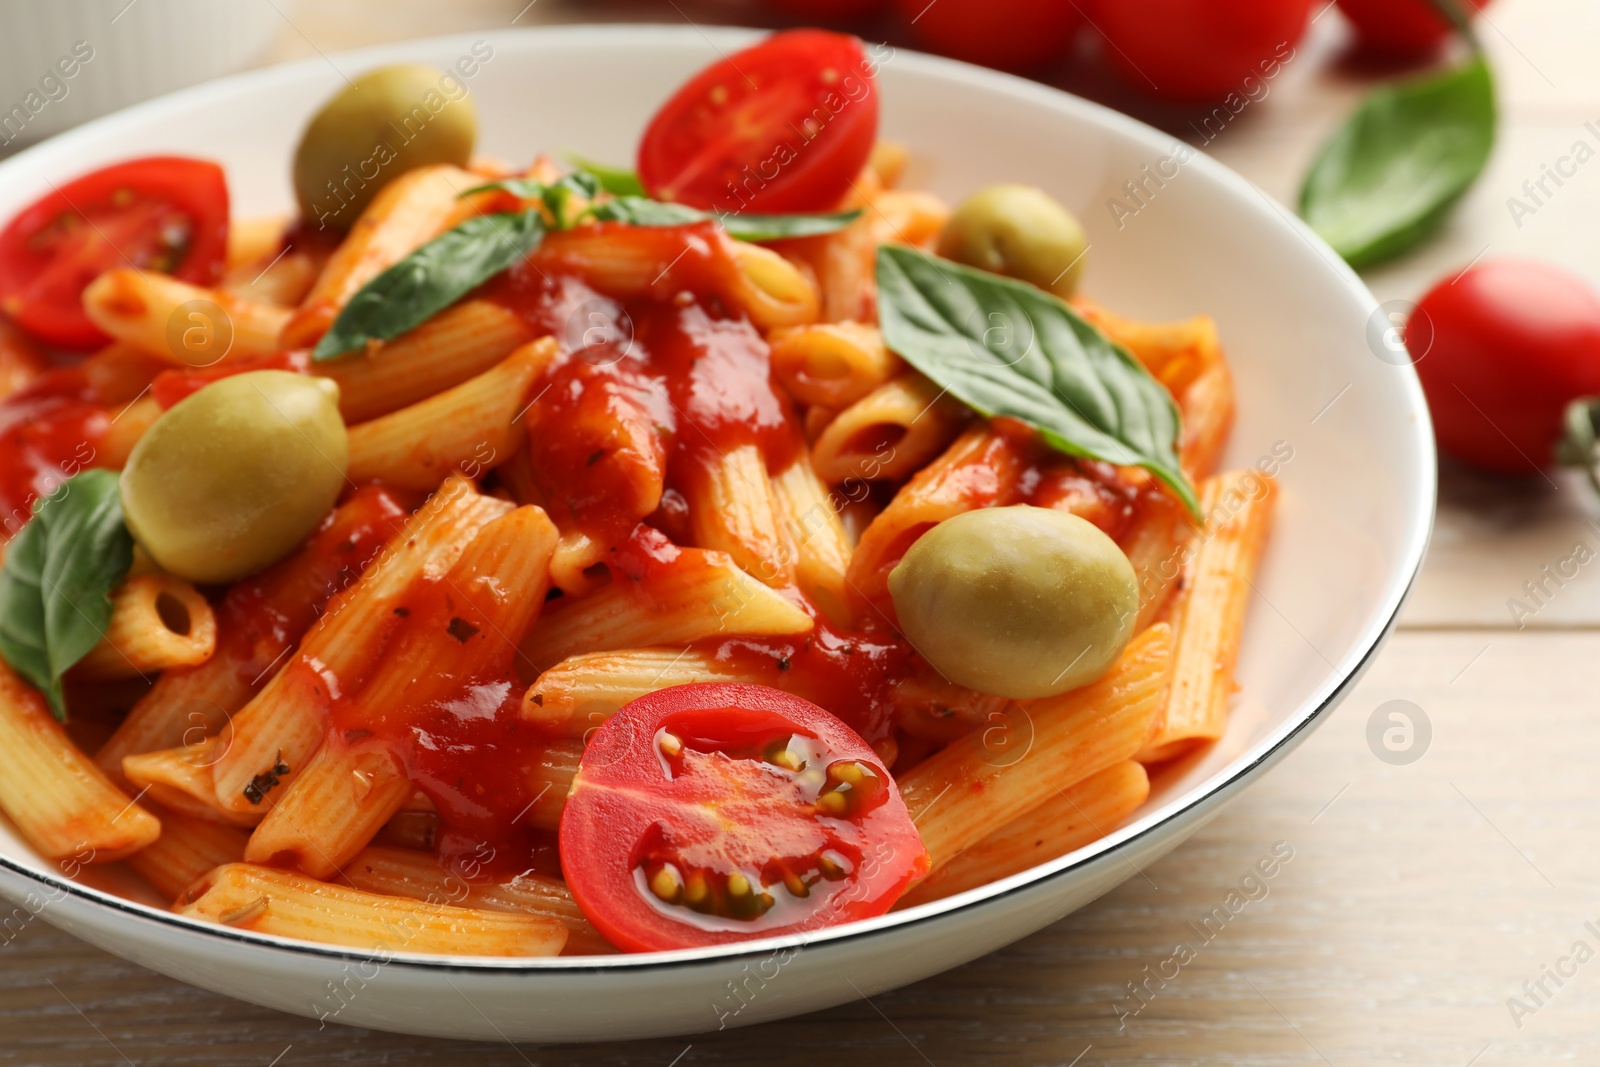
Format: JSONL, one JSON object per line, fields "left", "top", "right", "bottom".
{"left": 638, "top": 30, "right": 878, "bottom": 213}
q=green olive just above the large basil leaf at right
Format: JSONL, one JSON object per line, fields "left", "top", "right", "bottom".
{"left": 939, "top": 186, "right": 1088, "bottom": 299}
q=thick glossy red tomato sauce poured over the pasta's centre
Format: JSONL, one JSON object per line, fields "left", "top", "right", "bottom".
{"left": 485, "top": 224, "right": 803, "bottom": 545}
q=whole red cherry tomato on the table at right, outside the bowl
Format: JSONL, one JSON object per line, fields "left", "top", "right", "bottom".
{"left": 1408, "top": 259, "right": 1600, "bottom": 474}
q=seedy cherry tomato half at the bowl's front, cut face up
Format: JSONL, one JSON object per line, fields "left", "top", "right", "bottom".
{"left": 560, "top": 685, "right": 928, "bottom": 952}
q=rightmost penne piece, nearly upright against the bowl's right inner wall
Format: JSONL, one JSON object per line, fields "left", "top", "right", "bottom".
{"left": 1138, "top": 470, "right": 1277, "bottom": 763}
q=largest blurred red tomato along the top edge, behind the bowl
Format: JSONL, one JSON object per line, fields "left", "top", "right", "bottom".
{"left": 1096, "top": 0, "right": 1312, "bottom": 102}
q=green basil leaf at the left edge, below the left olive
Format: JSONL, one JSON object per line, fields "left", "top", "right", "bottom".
{"left": 0, "top": 470, "right": 133, "bottom": 720}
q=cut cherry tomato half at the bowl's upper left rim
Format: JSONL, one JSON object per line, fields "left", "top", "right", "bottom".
{"left": 0, "top": 155, "right": 227, "bottom": 349}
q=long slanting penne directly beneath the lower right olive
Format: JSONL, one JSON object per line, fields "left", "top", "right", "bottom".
{"left": 899, "top": 622, "right": 1173, "bottom": 872}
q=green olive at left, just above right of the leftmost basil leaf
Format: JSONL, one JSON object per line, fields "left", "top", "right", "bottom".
{"left": 122, "top": 371, "right": 349, "bottom": 582}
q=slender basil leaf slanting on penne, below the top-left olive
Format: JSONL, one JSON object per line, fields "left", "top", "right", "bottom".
{"left": 312, "top": 208, "right": 546, "bottom": 363}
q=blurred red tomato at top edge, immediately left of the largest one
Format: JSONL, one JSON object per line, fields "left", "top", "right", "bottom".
{"left": 898, "top": 0, "right": 1083, "bottom": 70}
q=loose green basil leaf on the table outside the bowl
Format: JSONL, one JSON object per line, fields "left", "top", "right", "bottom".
{"left": 1301, "top": 56, "right": 1496, "bottom": 267}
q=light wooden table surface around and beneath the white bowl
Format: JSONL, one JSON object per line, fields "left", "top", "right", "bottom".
{"left": 12, "top": 0, "right": 1600, "bottom": 1067}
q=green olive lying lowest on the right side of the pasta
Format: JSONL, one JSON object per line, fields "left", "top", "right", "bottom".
{"left": 890, "top": 506, "right": 1139, "bottom": 701}
